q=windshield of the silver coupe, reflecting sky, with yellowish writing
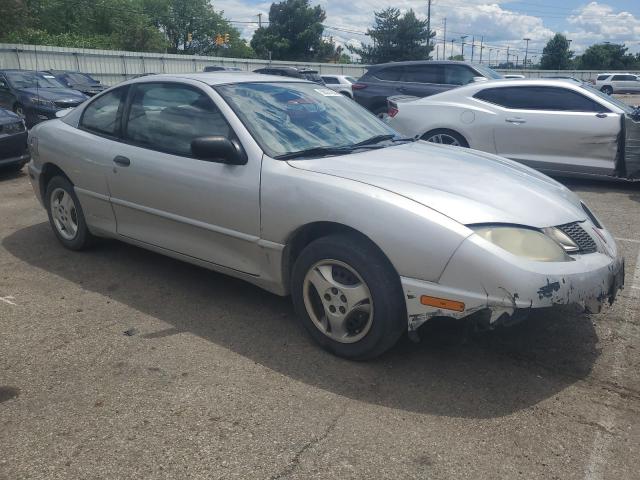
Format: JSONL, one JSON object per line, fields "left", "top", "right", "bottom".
{"left": 220, "top": 82, "right": 398, "bottom": 157}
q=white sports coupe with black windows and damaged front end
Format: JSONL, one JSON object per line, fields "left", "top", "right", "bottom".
{"left": 388, "top": 79, "right": 640, "bottom": 179}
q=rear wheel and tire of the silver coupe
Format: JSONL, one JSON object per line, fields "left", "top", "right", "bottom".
{"left": 45, "top": 176, "right": 94, "bottom": 250}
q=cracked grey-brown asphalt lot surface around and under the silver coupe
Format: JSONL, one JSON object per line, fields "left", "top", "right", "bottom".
{"left": 0, "top": 167, "right": 640, "bottom": 480}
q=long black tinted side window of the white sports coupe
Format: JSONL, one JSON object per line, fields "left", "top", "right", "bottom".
{"left": 474, "top": 87, "right": 607, "bottom": 112}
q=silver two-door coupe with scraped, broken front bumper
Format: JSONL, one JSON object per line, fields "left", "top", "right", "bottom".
{"left": 29, "top": 73, "right": 624, "bottom": 359}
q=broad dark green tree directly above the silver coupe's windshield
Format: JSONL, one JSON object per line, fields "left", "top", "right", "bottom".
{"left": 251, "top": 0, "right": 335, "bottom": 61}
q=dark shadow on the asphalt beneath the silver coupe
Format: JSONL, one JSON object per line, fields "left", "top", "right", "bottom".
{"left": 2, "top": 223, "right": 599, "bottom": 418}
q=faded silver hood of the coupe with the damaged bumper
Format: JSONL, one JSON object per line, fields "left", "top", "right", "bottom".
{"left": 289, "top": 141, "right": 586, "bottom": 228}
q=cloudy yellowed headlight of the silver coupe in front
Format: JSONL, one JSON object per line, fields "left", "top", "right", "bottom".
{"left": 473, "top": 226, "right": 573, "bottom": 262}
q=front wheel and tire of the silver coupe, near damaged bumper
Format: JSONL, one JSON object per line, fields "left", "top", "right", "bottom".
{"left": 291, "top": 234, "right": 407, "bottom": 360}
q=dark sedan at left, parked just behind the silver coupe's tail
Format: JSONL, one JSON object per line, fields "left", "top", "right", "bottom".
{"left": 0, "top": 70, "right": 88, "bottom": 128}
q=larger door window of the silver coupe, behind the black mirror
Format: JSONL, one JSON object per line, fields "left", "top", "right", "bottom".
{"left": 124, "top": 83, "right": 230, "bottom": 156}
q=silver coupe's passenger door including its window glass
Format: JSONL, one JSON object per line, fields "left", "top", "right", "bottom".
{"left": 109, "top": 82, "right": 261, "bottom": 274}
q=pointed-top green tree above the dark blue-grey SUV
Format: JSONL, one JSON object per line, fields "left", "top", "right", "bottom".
{"left": 347, "top": 7, "right": 435, "bottom": 63}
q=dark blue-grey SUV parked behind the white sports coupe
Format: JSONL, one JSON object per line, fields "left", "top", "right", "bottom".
{"left": 351, "top": 60, "right": 502, "bottom": 115}
